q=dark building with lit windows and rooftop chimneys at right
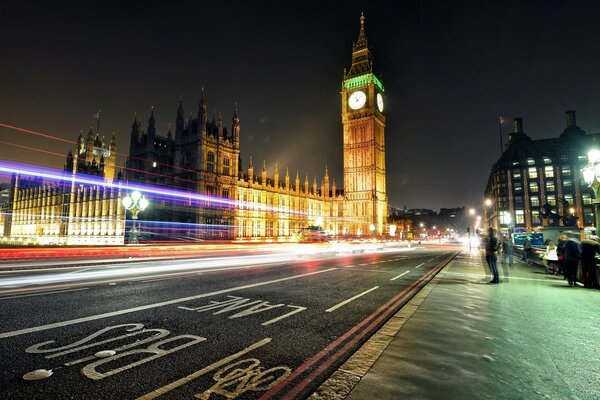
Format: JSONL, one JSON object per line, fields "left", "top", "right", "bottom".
{"left": 483, "top": 110, "right": 600, "bottom": 231}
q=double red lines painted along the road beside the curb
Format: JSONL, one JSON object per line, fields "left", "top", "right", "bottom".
{"left": 260, "top": 253, "right": 458, "bottom": 400}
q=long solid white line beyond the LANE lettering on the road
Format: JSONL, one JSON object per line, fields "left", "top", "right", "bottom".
{"left": 0, "top": 268, "right": 338, "bottom": 339}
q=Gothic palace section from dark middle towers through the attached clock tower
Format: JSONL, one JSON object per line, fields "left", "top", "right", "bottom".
{"left": 126, "top": 16, "right": 387, "bottom": 239}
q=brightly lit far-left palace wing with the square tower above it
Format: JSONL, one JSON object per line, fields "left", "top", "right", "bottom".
{"left": 4, "top": 129, "right": 125, "bottom": 245}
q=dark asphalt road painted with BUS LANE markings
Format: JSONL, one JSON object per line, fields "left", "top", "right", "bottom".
{"left": 0, "top": 247, "right": 455, "bottom": 399}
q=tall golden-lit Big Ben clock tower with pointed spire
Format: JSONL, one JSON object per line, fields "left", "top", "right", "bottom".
{"left": 341, "top": 14, "right": 387, "bottom": 235}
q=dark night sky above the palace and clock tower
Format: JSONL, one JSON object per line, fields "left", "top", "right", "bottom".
{"left": 0, "top": 0, "right": 600, "bottom": 209}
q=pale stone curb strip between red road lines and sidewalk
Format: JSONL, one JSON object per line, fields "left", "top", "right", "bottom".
{"left": 308, "top": 252, "right": 462, "bottom": 400}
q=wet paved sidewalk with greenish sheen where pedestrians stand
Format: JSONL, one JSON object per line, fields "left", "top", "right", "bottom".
{"left": 311, "top": 251, "right": 600, "bottom": 400}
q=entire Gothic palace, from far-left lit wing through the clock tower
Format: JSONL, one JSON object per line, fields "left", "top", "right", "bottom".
{"left": 4, "top": 15, "right": 387, "bottom": 244}
